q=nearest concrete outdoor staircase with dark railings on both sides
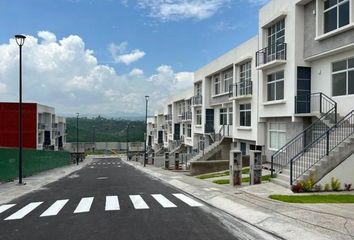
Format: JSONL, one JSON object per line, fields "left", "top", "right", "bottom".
{"left": 271, "top": 92, "right": 354, "bottom": 187}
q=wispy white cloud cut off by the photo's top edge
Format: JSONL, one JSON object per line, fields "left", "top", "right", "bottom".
{"left": 138, "top": 0, "right": 230, "bottom": 21}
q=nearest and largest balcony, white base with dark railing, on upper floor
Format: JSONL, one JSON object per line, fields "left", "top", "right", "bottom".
{"left": 256, "top": 43, "right": 287, "bottom": 70}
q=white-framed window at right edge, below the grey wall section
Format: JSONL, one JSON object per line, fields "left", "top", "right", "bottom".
{"left": 332, "top": 58, "right": 354, "bottom": 96}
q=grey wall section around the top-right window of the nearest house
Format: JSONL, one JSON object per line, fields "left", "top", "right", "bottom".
{"left": 304, "top": 1, "right": 354, "bottom": 58}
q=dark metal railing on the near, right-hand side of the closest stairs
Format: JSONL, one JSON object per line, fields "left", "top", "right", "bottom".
{"left": 290, "top": 110, "right": 354, "bottom": 185}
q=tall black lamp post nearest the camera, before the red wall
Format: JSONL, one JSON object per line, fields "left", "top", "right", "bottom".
{"left": 15, "top": 35, "right": 26, "bottom": 184}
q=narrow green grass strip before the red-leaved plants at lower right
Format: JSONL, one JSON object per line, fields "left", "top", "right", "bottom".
{"left": 269, "top": 194, "right": 354, "bottom": 203}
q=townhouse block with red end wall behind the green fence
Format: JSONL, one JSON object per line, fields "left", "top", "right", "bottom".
{"left": 0, "top": 102, "right": 67, "bottom": 150}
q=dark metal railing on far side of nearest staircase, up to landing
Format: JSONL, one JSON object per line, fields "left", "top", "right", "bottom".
{"left": 271, "top": 93, "right": 337, "bottom": 176}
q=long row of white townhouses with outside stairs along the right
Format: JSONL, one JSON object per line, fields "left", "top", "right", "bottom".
{"left": 147, "top": 0, "right": 354, "bottom": 186}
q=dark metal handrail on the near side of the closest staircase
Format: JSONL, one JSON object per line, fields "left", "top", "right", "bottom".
{"left": 290, "top": 109, "right": 354, "bottom": 185}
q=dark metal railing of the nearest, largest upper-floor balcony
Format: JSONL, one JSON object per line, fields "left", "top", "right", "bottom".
{"left": 256, "top": 43, "right": 287, "bottom": 67}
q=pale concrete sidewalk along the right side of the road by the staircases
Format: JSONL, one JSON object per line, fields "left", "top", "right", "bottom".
{"left": 125, "top": 158, "right": 354, "bottom": 240}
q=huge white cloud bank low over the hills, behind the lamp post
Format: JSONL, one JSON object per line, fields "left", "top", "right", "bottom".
{"left": 0, "top": 32, "right": 193, "bottom": 115}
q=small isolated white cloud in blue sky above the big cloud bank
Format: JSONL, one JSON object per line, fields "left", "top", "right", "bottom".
{"left": 108, "top": 42, "right": 145, "bottom": 65}
